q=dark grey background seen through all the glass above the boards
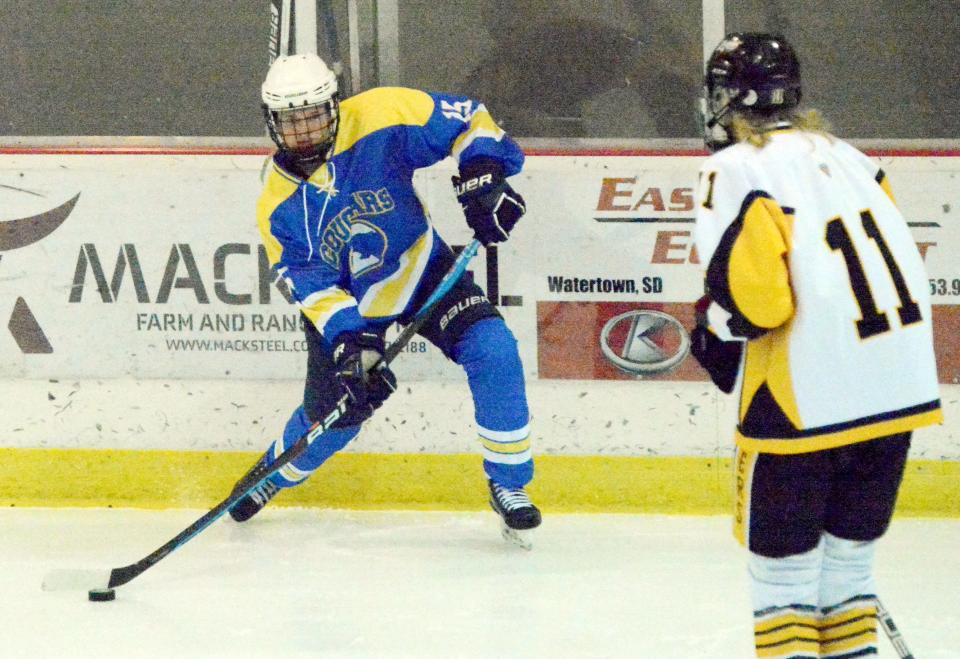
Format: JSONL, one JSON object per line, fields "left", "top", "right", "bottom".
{"left": 0, "top": 0, "right": 960, "bottom": 139}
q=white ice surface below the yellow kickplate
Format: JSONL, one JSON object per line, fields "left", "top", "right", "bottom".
{"left": 0, "top": 509, "right": 960, "bottom": 659}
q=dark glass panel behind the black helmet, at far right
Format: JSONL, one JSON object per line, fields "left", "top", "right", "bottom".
{"left": 726, "top": 0, "right": 960, "bottom": 138}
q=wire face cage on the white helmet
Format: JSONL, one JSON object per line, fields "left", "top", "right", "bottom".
{"left": 263, "top": 95, "right": 340, "bottom": 160}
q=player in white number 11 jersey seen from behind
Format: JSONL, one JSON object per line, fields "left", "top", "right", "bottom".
{"left": 691, "top": 33, "right": 942, "bottom": 658}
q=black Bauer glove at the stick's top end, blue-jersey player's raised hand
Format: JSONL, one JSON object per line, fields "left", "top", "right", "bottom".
{"left": 451, "top": 158, "right": 527, "bottom": 247}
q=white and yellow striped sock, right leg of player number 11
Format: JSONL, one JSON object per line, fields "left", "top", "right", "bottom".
{"left": 819, "top": 533, "right": 877, "bottom": 659}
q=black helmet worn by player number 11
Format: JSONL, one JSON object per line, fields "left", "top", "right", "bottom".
{"left": 700, "top": 32, "right": 801, "bottom": 151}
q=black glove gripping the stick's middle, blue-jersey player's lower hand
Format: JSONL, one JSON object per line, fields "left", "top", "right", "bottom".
{"left": 333, "top": 332, "right": 397, "bottom": 426}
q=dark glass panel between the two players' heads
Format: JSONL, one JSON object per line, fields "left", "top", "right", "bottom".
{"left": 399, "top": 0, "right": 703, "bottom": 138}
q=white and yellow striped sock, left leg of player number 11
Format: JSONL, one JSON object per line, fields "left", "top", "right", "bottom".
{"left": 749, "top": 541, "right": 823, "bottom": 659}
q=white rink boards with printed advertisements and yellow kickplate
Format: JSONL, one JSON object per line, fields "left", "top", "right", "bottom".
{"left": 0, "top": 148, "right": 960, "bottom": 515}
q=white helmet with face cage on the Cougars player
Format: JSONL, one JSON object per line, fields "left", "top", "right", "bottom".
{"left": 260, "top": 53, "right": 340, "bottom": 160}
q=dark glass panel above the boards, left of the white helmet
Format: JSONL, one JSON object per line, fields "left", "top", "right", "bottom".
{"left": 0, "top": 0, "right": 350, "bottom": 137}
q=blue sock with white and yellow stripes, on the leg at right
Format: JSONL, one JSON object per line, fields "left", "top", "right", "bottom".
{"left": 454, "top": 318, "right": 533, "bottom": 489}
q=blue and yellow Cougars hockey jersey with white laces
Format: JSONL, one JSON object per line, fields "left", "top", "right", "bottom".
{"left": 257, "top": 87, "right": 523, "bottom": 341}
